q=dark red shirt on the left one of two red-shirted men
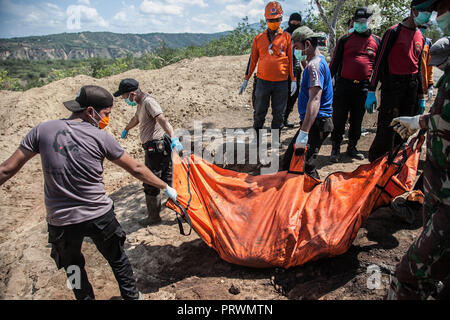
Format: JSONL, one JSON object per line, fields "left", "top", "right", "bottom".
{"left": 341, "top": 32, "right": 378, "bottom": 81}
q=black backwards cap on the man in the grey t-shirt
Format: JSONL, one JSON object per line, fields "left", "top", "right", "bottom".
{"left": 63, "top": 86, "right": 114, "bottom": 113}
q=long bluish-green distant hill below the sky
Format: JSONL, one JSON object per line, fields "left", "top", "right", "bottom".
{"left": 0, "top": 32, "right": 228, "bottom": 61}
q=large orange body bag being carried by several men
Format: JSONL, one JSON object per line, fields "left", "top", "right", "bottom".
{"left": 168, "top": 136, "right": 424, "bottom": 268}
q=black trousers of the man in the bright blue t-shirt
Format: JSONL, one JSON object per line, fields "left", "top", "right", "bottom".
{"left": 281, "top": 118, "right": 333, "bottom": 179}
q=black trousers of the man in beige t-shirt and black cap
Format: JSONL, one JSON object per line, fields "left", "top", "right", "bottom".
{"left": 143, "top": 135, "right": 173, "bottom": 197}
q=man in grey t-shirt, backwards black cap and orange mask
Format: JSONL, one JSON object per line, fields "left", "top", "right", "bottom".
{"left": 0, "top": 86, "right": 177, "bottom": 300}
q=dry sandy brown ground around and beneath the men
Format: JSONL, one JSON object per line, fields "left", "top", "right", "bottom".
{"left": 0, "top": 56, "right": 442, "bottom": 300}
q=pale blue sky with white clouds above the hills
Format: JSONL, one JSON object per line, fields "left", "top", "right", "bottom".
{"left": 0, "top": 0, "right": 310, "bottom": 38}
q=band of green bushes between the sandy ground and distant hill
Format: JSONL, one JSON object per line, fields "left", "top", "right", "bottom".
{"left": 0, "top": 18, "right": 261, "bottom": 90}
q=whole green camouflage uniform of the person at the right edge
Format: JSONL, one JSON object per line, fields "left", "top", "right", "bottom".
{"left": 388, "top": 66, "right": 450, "bottom": 300}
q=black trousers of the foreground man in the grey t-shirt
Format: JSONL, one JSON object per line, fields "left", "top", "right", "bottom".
{"left": 48, "top": 208, "right": 139, "bottom": 300}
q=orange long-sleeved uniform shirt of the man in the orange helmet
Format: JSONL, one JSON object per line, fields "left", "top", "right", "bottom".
{"left": 245, "top": 28, "right": 297, "bottom": 82}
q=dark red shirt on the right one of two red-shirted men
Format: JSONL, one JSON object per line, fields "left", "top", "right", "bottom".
{"left": 388, "top": 26, "right": 424, "bottom": 75}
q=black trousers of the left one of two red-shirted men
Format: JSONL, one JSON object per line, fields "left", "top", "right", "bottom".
{"left": 331, "top": 80, "right": 368, "bottom": 145}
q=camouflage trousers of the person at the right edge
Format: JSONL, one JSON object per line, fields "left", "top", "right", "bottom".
{"left": 388, "top": 165, "right": 450, "bottom": 300}
